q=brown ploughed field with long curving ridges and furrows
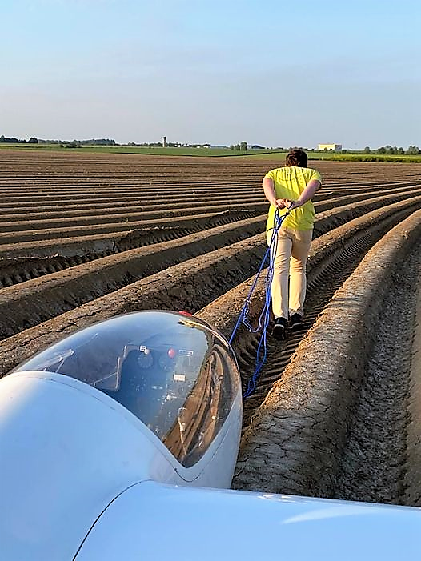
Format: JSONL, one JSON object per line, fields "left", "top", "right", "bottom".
{"left": 0, "top": 150, "right": 421, "bottom": 506}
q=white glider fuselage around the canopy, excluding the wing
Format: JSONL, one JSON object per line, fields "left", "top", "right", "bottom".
{"left": 0, "top": 372, "right": 242, "bottom": 561}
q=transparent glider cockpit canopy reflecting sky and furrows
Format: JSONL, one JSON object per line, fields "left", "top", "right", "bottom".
{"left": 17, "top": 311, "right": 240, "bottom": 467}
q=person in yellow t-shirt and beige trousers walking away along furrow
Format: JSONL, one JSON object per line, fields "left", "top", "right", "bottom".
{"left": 263, "top": 149, "right": 322, "bottom": 339}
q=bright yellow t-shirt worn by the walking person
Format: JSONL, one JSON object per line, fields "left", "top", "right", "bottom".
{"left": 265, "top": 166, "right": 322, "bottom": 230}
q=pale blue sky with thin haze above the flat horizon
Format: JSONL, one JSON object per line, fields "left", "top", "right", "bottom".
{"left": 0, "top": 0, "right": 421, "bottom": 149}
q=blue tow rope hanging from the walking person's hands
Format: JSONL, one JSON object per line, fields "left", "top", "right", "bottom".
{"left": 229, "top": 208, "right": 290, "bottom": 398}
